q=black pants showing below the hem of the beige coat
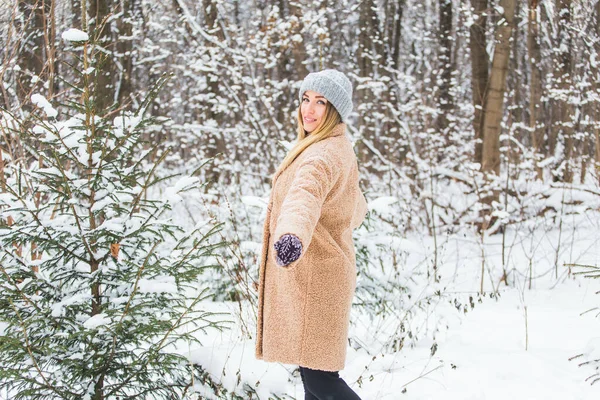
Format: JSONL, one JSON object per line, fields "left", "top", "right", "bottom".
{"left": 300, "top": 367, "right": 360, "bottom": 400}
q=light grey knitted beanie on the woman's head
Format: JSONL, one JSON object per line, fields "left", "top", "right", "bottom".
{"left": 299, "top": 69, "right": 352, "bottom": 123}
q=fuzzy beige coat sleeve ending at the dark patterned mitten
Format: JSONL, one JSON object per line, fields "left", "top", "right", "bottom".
{"left": 273, "top": 155, "right": 341, "bottom": 263}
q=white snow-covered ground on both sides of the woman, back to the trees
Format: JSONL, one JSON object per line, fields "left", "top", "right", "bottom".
{"left": 0, "top": 188, "right": 600, "bottom": 400}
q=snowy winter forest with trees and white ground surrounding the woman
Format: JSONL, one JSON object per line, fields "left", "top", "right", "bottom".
{"left": 0, "top": 0, "right": 600, "bottom": 400}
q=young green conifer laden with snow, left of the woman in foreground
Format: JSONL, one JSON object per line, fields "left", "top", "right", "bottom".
{"left": 0, "top": 69, "right": 229, "bottom": 400}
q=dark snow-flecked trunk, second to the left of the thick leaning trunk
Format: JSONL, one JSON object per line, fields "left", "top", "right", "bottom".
{"left": 436, "top": 0, "right": 454, "bottom": 141}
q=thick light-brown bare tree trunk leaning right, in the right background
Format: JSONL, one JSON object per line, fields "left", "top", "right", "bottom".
{"left": 481, "top": 0, "right": 516, "bottom": 175}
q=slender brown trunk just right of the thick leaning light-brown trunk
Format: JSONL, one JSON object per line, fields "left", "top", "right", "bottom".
{"left": 527, "top": 0, "right": 543, "bottom": 180}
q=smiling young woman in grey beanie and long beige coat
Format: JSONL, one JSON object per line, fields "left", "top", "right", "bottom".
{"left": 256, "top": 70, "right": 367, "bottom": 400}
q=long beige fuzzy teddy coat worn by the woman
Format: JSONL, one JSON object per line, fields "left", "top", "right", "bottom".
{"left": 256, "top": 124, "right": 367, "bottom": 371}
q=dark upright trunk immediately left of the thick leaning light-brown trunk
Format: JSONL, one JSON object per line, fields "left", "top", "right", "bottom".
{"left": 469, "top": 0, "right": 489, "bottom": 163}
